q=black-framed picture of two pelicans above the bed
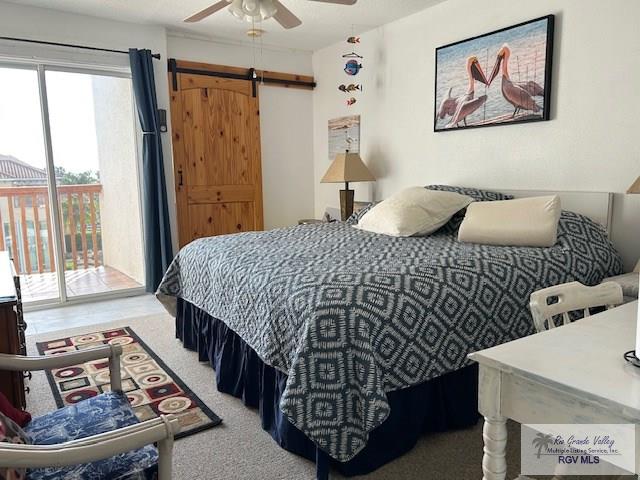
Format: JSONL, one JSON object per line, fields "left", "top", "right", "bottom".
{"left": 433, "top": 15, "right": 554, "bottom": 132}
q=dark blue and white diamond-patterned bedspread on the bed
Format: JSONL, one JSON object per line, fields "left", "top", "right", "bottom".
{"left": 158, "top": 212, "right": 621, "bottom": 461}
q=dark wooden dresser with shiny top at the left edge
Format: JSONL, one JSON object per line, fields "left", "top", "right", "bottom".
{"left": 0, "top": 252, "right": 27, "bottom": 408}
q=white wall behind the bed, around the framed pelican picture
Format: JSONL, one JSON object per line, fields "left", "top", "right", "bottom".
{"left": 313, "top": 0, "right": 640, "bottom": 268}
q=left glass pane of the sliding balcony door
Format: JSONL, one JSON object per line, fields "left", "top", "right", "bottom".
{"left": 0, "top": 65, "right": 60, "bottom": 302}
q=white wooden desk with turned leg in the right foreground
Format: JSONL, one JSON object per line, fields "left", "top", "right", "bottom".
{"left": 469, "top": 302, "right": 640, "bottom": 480}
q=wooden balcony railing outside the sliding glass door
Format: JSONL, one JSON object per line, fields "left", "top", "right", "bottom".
{"left": 0, "top": 184, "right": 102, "bottom": 274}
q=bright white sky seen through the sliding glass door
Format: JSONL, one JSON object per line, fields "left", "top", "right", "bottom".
{"left": 0, "top": 68, "right": 98, "bottom": 172}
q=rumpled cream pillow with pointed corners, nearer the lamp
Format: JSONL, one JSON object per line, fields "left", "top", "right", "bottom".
{"left": 355, "top": 187, "right": 473, "bottom": 237}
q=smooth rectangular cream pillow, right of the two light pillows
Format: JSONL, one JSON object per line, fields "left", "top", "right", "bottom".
{"left": 458, "top": 195, "right": 561, "bottom": 247}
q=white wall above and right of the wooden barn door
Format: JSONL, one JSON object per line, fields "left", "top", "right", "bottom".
{"left": 167, "top": 33, "right": 315, "bottom": 229}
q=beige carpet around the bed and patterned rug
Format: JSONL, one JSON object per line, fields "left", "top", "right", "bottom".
{"left": 27, "top": 314, "right": 520, "bottom": 480}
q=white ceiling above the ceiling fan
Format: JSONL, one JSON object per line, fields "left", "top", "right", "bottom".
{"left": 9, "top": 0, "right": 444, "bottom": 50}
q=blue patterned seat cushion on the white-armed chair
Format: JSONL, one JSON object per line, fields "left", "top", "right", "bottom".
{"left": 25, "top": 392, "right": 158, "bottom": 480}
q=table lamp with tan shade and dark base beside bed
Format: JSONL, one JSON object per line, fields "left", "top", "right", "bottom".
{"left": 320, "top": 150, "right": 375, "bottom": 222}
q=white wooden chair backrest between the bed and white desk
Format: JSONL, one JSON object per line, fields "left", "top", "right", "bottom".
{"left": 529, "top": 282, "right": 623, "bottom": 332}
